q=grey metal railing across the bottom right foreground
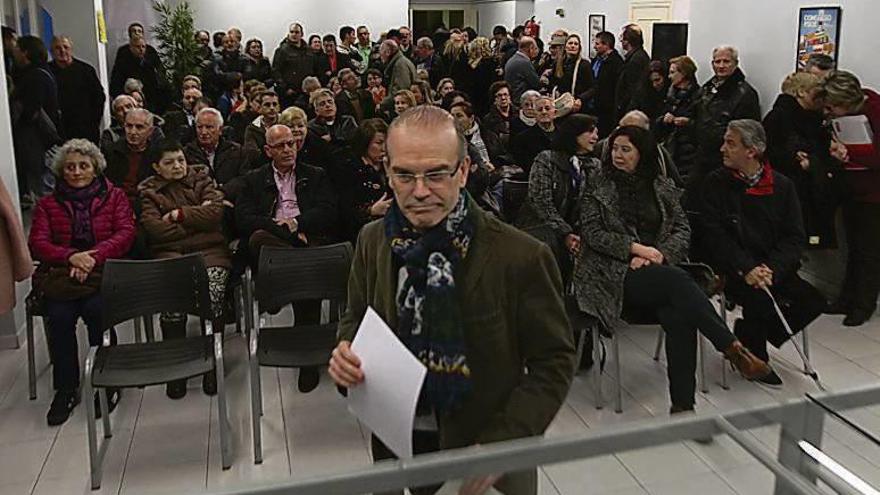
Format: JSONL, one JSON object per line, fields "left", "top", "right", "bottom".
{"left": 206, "top": 385, "right": 880, "bottom": 495}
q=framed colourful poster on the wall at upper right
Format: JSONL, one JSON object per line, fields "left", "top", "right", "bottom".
{"left": 795, "top": 7, "right": 841, "bottom": 70}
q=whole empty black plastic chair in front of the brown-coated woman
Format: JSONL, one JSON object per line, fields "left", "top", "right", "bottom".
{"left": 83, "top": 254, "right": 232, "bottom": 490}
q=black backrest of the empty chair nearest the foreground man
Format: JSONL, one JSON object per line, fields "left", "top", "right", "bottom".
{"left": 254, "top": 242, "right": 353, "bottom": 314}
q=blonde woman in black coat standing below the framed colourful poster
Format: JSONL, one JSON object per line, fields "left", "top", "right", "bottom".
{"left": 763, "top": 72, "right": 844, "bottom": 249}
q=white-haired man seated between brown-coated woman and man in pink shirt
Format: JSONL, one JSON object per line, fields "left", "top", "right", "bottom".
{"left": 183, "top": 107, "right": 250, "bottom": 198}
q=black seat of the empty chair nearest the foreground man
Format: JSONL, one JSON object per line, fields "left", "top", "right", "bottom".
{"left": 257, "top": 322, "right": 337, "bottom": 368}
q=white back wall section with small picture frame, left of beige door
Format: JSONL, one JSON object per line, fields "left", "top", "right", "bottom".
{"left": 535, "top": 0, "right": 628, "bottom": 46}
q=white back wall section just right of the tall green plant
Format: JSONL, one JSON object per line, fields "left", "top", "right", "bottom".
{"left": 169, "top": 0, "right": 409, "bottom": 59}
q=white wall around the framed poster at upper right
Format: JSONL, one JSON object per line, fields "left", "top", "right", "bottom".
{"left": 689, "top": 0, "right": 880, "bottom": 111}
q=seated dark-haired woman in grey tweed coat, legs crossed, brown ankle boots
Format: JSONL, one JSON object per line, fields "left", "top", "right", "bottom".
{"left": 574, "top": 126, "right": 770, "bottom": 413}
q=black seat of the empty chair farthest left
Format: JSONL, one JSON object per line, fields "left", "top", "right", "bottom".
{"left": 92, "top": 335, "right": 214, "bottom": 387}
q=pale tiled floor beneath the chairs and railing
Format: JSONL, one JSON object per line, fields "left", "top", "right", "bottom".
{"left": 0, "top": 308, "right": 880, "bottom": 495}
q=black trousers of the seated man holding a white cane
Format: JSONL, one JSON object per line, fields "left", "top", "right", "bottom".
{"left": 724, "top": 275, "right": 825, "bottom": 361}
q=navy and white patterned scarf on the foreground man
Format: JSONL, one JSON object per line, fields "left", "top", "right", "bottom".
{"left": 385, "top": 191, "right": 474, "bottom": 414}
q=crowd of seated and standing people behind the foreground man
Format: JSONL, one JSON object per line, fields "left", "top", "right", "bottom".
{"left": 16, "top": 16, "right": 880, "bottom": 476}
